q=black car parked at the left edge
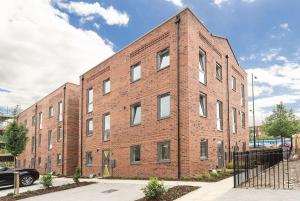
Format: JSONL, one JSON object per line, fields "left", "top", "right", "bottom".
{"left": 0, "top": 167, "right": 40, "bottom": 186}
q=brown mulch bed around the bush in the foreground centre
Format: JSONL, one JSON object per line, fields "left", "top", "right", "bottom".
{"left": 136, "top": 186, "right": 199, "bottom": 201}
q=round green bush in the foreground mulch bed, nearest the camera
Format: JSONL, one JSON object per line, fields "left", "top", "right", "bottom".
{"left": 142, "top": 177, "right": 166, "bottom": 199}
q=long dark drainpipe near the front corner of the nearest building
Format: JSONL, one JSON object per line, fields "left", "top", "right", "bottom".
{"left": 175, "top": 15, "right": 181, "bottom": 179}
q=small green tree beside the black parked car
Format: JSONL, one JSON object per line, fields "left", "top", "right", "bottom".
{"left": 3, "top": 118, "right": 28, "bottom": 167}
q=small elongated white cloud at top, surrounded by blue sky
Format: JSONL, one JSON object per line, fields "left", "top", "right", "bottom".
{"left": 53, "top": 0, "right": 129, "bottom": 25}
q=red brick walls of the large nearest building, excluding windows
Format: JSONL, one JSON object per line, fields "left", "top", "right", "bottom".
{"left": 81, "top": 10, "right": 248, "bottom": 177}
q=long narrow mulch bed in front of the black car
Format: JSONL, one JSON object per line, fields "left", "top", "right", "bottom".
{"left": 0, "top": 182, "right": 95, "bottom": 201}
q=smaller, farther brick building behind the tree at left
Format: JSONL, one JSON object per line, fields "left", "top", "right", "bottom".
{"left": 17, "top": 83, "right": 80, "bottom": 175}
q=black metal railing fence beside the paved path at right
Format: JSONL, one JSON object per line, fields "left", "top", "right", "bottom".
{"left": 233, "top": 148, "right": 290, "bottom": 188}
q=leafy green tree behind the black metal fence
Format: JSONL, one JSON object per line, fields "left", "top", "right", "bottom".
{"left": 263, "top": 102, "right": 300, "bottom": 137}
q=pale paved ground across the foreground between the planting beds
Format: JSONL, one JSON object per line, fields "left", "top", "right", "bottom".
{"left": 0, "top": 175, "right": 300, "bottom": 201}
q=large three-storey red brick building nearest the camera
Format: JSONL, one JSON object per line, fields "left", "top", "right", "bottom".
{"left": 79, "top": 9, "right": 249, "bottom": 178}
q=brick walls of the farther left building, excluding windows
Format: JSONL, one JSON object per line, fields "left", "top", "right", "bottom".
{"left": 18, "top": 83, "right": 80, "bottom": 175}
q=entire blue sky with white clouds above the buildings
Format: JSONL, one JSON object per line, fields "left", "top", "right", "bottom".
{"left": 0, "top": 0, "right": 300, "bottom": 124}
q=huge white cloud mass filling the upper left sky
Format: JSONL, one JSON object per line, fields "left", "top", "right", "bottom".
{"left": 0, "top": 0, "right": 113, "bottom": 108}
